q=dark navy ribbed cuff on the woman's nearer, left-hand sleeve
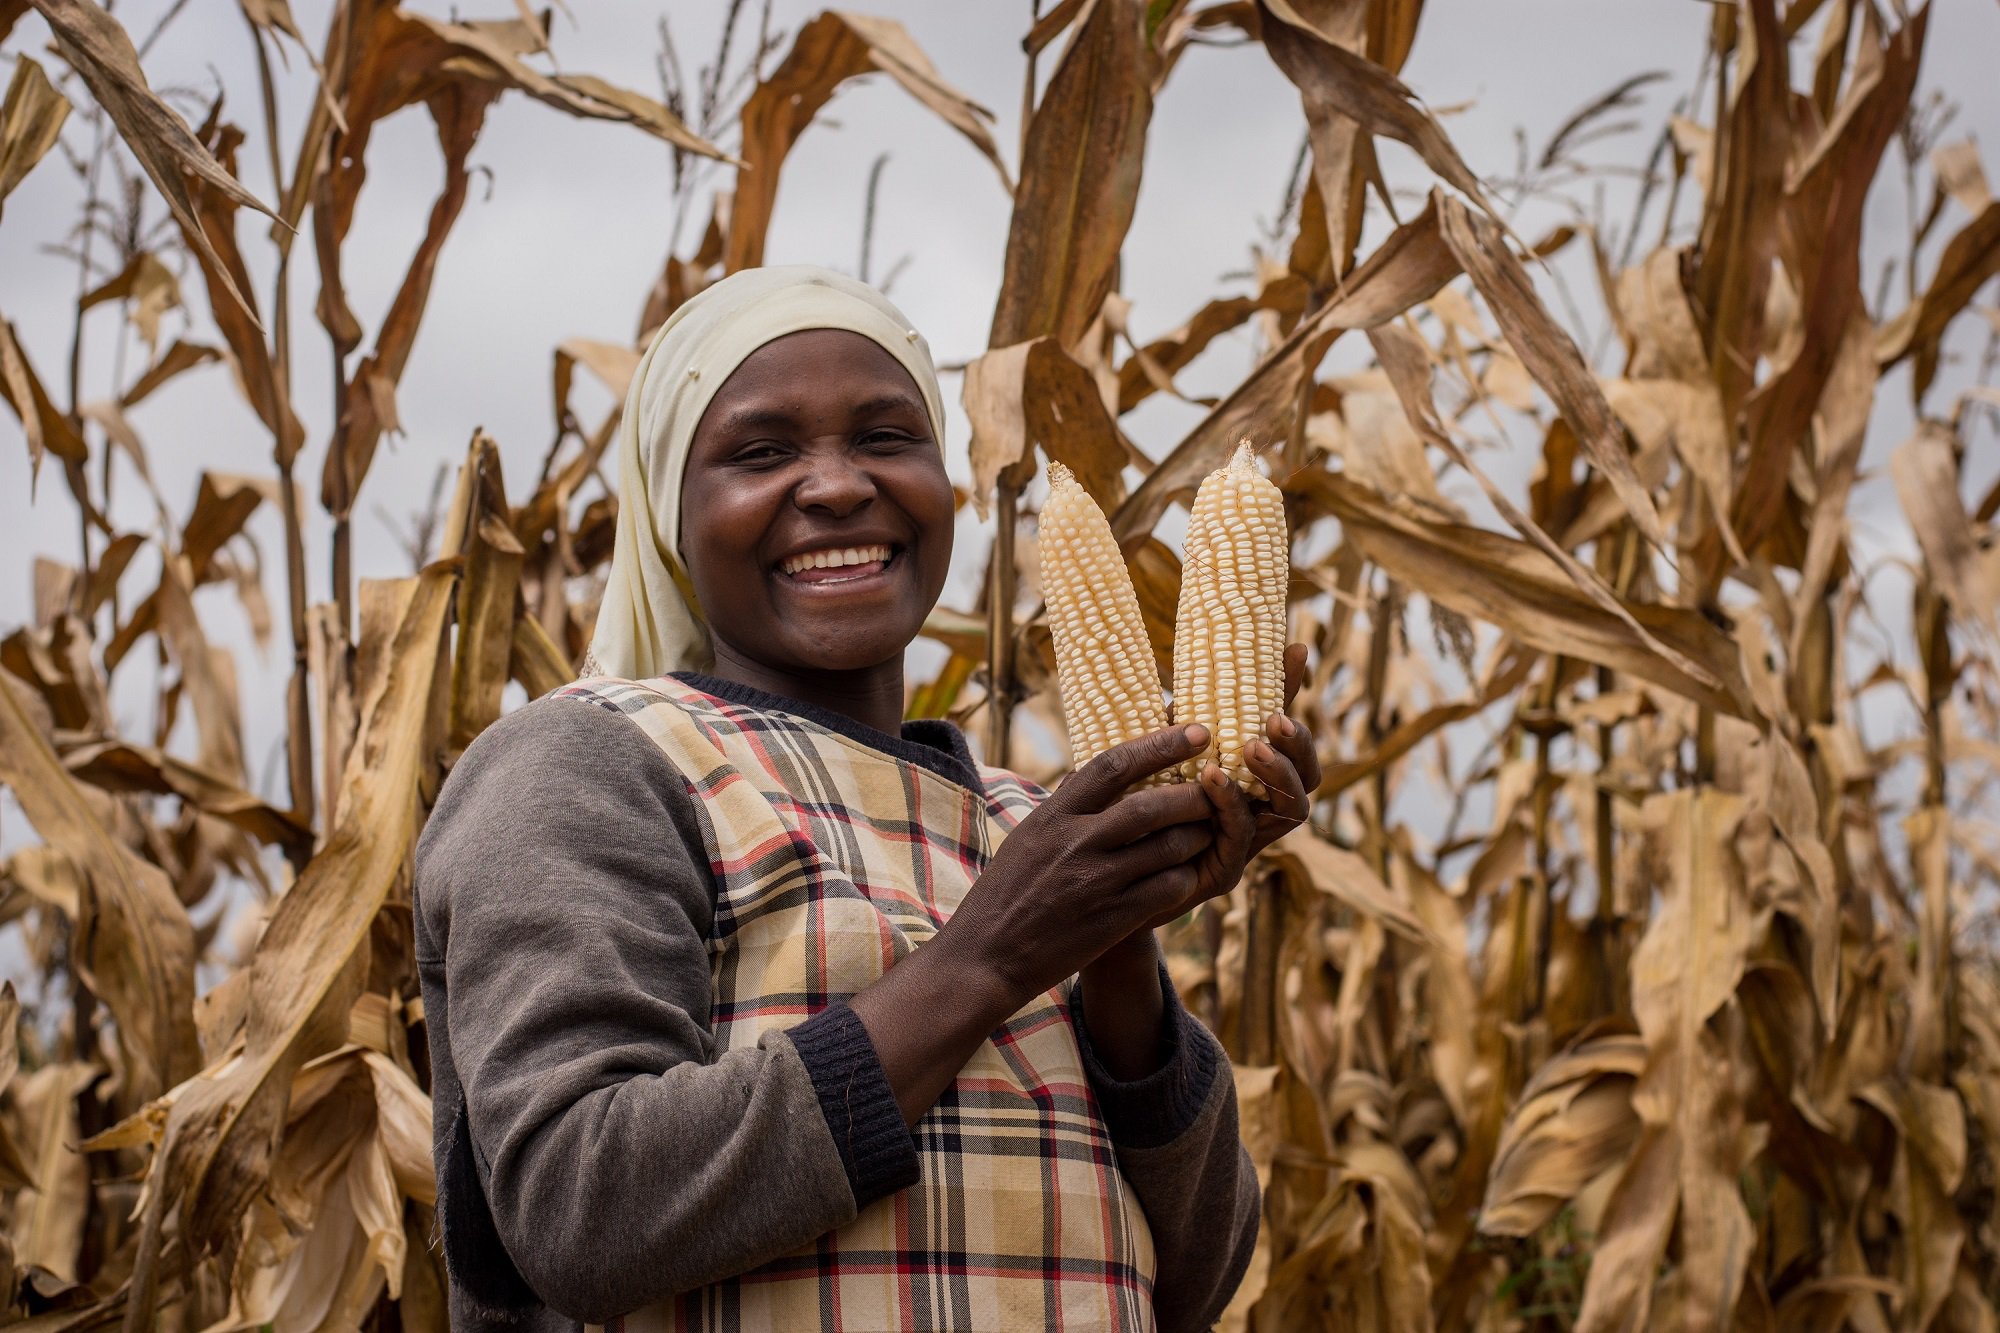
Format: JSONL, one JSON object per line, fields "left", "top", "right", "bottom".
{"left": 786, "top": 1005, "right": 922, "bottom": 1209}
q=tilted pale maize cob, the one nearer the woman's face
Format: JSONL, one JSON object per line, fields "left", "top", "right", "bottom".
{"left": 1040, "top": 462, "right": 1174, "bottom": 781}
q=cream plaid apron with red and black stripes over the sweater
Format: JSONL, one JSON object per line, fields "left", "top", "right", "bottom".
{"left": 564, "top": 677, "right": 1154, "bottom": 1333}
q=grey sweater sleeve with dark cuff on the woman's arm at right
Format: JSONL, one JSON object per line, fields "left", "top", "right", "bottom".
{"left": 1072, "top": 967, "right": 1262, "bottom": 1333}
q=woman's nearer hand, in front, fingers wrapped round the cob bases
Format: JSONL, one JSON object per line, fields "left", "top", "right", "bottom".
{"left": 934, "top": 725, "right": 1226, "bottom": 1011}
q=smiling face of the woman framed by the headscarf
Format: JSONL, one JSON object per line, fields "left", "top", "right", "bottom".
{"left": 680, "top": 328, "right": 952, "bottom": 673}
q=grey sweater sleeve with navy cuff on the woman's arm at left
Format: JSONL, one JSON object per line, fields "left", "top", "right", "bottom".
{"left": 416, "top": 699, "right": 916, "bottom": 1323}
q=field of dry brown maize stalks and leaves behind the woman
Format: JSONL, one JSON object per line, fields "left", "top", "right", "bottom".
{"left": 0, "top": 0, "right": 2000, "bottom": 1333}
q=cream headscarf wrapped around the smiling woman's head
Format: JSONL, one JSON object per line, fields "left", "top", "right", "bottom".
{"left": 582, "top": 264, "right": 944, "bottom": 681}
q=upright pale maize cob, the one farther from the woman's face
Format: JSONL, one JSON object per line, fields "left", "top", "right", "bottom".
{"left": 1174, "top": 440, "right": 1292, "bottom": 799}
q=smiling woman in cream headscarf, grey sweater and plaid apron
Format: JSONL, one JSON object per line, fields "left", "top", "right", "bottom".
{"left": 416, "top": 268, "right": 1318, "bottom": 1329}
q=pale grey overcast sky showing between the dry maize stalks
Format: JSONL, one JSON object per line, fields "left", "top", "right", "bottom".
{"left": 0, "top": 0, "right": 2000, "bottom": 808}
